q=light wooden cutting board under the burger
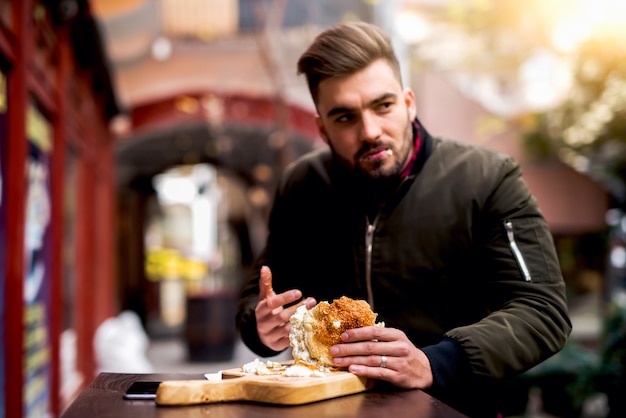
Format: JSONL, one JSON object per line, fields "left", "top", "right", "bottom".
{"left": 155, "top": 369, "right": 366, "bottom": 405}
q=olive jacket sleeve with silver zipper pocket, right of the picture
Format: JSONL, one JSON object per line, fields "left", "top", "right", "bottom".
{"left": 445, "top": 158, "right": 571, "bottom": 379}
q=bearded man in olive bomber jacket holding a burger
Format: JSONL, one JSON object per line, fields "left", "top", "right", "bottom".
{"left": 237, "top": 23, "right": 571, "bottom": 416}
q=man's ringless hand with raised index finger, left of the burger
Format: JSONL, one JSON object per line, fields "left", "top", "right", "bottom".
{"left": 254, "top": 266, "right": 317, "bottom": 351}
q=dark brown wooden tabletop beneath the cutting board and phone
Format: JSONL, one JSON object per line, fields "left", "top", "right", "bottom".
{"left": 61, "top": 373, "right": 465, "bottom": 418}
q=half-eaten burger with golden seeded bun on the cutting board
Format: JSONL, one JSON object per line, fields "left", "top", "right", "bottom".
{"left": 289, "top": 296, "right": 384, "bottom": 367}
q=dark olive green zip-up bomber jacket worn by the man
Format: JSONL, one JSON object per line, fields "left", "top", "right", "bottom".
{"left": 237, "top": 123, "right": 571, "bottom": 414}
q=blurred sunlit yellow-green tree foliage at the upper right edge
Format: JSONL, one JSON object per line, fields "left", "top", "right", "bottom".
{"left": 532, "top": 37, "right": 626, "bottom": 202}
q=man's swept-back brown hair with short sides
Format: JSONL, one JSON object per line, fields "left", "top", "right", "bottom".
{"left": 298, "top": 22, "right": 402, "bottom": 102}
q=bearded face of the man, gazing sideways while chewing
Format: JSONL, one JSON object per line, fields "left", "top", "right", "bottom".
{"left": 316, "top": 59, "right": 416, "bottom": 178}
